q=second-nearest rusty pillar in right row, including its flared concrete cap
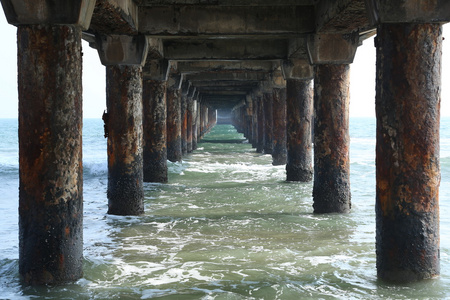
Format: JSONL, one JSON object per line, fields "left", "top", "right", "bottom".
{"left": 308, "top": 34, "right": 359, "bottom": 213}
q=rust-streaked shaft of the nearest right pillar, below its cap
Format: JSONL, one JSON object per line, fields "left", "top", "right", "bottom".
{"left": 376, "top": 24, "right": 442, "bottom": 281}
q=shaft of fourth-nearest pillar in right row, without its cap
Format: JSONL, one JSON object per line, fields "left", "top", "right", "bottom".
{"left": 272, "top": 88, "right": 287, "bottom": 166}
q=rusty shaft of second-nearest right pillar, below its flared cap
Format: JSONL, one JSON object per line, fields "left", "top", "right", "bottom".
{"left": 313, "top": 64, "right": 351, "bottom": 213}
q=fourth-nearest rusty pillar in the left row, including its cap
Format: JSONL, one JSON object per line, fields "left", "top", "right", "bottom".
{"left": 166, "top": 68, "right": 183, "bottom": 162}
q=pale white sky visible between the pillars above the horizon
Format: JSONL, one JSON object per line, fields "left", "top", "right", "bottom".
{"left": 0, "top": 12, "right": 450, "bottom": 118}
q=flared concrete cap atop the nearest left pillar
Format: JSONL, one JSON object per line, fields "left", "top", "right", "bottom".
{"left": 1, "top": 0, "right": 95, "bottom": 30}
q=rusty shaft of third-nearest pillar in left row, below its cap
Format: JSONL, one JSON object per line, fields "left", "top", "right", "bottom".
{"left": 142, "top": 80, "right": 167, "bottom": 182}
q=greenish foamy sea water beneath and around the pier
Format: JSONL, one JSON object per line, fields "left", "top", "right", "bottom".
{"left": 0, "top": 118, "right": 450, "bottom": 300}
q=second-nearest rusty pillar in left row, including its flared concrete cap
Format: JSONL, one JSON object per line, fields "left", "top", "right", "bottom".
{"left": 97, "top": 35, "right": 148, "bottom": 215}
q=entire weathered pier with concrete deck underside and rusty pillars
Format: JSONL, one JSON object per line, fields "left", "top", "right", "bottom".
{"left": 1, "top": 0, "right": 450, "bottom": 285}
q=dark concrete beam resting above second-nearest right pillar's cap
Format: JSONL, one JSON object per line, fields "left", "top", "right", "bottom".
{"left": 316, "top": 0, "right": 371, "bottom": 33}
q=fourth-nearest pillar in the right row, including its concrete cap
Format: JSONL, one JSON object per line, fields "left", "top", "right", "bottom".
{"left": 271, "top": 68, "right": 287, "bottom": 166}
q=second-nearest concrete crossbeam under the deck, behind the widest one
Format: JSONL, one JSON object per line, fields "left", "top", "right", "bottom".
{"left": 164, "top": 39, "right": 288, "bottom": 60}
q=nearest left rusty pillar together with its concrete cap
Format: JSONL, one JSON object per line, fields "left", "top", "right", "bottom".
{"left": 2, "top": 1, "right": 95, "bottom": 285}
